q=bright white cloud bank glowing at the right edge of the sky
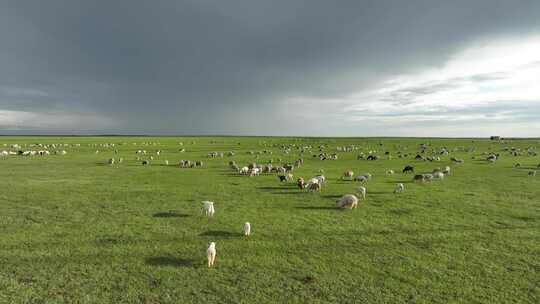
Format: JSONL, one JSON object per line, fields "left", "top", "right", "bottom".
{"left": 348, "top": 36, "right": 540, "bottom": 113}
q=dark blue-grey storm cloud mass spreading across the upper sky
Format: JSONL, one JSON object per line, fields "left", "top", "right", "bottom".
{"left": 0, "top": 0, "right": 540, "bottom": 135}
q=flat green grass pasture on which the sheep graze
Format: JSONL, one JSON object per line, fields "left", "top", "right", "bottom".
{"left": 0, "top": 137, "right": 540, "bottom": 303}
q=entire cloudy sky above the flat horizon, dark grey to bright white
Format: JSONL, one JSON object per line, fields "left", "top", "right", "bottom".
{"left": 0, "top": 0, "right": 540, "bottom": 137}
